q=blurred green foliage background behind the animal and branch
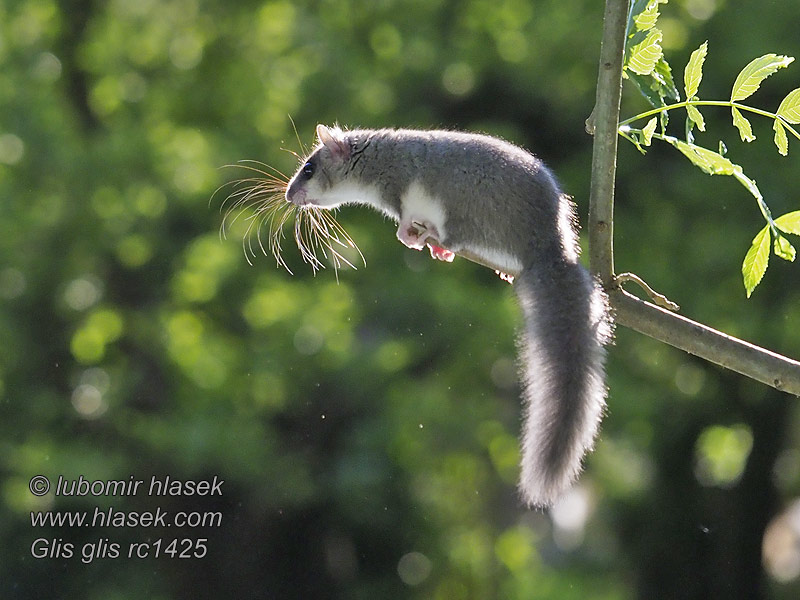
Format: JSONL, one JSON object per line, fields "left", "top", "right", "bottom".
{"left": 0, "top": 0, "right": 800, "bottom": 600}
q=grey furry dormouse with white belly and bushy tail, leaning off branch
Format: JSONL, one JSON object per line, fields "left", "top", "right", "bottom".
{"left": 286, "top": 125, "right": 612, "bottom": 507}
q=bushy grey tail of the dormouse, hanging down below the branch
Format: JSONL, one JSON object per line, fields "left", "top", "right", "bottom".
{"left": 514, "top": 261, "right": 612, "bottom": 506}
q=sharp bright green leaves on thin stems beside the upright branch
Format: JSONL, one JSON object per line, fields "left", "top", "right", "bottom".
{"left": 619, "top": 0, "right": 800, "bottom": 298}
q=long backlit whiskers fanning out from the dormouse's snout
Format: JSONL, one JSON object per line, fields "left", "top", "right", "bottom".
{"left": 212, "top": 160, "right": 366, "bottom": 280}
